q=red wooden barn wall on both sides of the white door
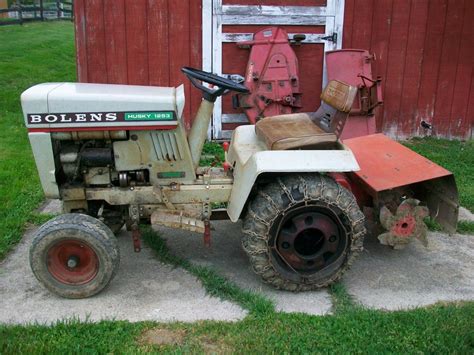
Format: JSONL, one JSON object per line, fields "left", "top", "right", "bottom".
{"left": 75, "top": 0, "right": 474, "bottom": 138}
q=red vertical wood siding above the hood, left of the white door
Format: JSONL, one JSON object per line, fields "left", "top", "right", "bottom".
{"left": 74, "top": 0, "right": 202, "bottom": 128}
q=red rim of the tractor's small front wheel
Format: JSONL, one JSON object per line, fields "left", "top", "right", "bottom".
{"left": 47, "top": 239, "right": 99, "bottom": 285}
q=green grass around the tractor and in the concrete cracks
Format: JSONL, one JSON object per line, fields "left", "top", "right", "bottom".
{"left": 0, "top": 22, "right": 474, "bottom": 354}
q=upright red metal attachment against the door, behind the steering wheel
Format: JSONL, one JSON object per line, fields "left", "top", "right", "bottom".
{"left": 234, "top": 27, "right": 303, "bottom": 124}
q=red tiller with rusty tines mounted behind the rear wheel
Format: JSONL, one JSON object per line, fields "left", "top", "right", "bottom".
{"left": 344, "top": 134, "right": 459, "bottom": 249}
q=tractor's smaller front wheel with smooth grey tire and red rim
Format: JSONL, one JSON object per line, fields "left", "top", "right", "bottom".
{"left": 30, "top": 213, "right": 120, "bottom": 298}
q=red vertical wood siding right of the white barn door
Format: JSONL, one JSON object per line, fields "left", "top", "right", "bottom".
{"left": 343, "top": 0, "right": 474, "bottom": 139}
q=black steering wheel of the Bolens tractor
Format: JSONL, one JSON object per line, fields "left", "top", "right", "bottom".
{"left": 181, "top": 67, "right": 249, "bottom": 102}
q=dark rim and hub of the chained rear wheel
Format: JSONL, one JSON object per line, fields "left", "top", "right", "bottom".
{"left": 273, "top": 206, "right": 347, "bottom": 273}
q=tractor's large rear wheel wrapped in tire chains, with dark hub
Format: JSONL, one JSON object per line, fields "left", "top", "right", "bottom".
{"left": 243, "top": 174, "right": 365, "bottom": 291}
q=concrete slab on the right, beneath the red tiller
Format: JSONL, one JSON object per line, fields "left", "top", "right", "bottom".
{"left": 343, "top": 233, "right": 474, "bottom": 310}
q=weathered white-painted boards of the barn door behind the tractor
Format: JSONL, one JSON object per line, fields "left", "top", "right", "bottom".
{"left": 202, "top": 0, "right": 344, "bottom": 140}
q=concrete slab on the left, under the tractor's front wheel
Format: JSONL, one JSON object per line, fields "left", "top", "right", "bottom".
{"left": 0, "top": 230, "right": 246, "bottom": 324}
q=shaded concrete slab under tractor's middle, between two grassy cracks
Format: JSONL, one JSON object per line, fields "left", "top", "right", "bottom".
{"left": 163, "top": 221, "right": 332, "bottom": 315}
